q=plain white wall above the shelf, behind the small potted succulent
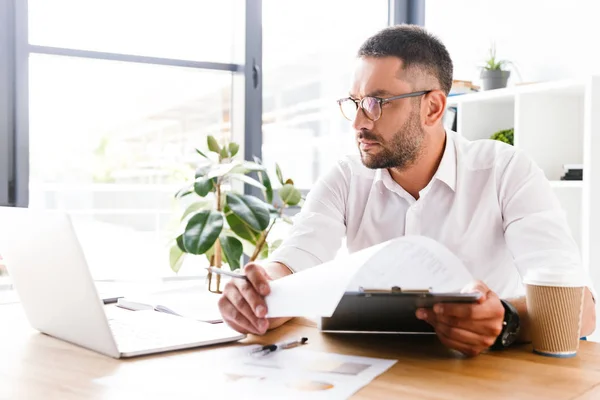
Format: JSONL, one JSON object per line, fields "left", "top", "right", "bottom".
{"left": 425, "top": 0, "right": 600, "bottom": 85}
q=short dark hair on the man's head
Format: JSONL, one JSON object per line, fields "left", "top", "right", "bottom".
{"left": 358, "top": 24, "right": 452, "bottom": 95}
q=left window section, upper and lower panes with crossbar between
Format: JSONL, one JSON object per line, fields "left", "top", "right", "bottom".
{"left": 15, "top": 0, "right": 245, "bottom": 279}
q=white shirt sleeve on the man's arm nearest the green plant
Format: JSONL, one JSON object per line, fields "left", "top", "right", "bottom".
{"left": 269, "top": 160, "right": 351, "bottom": 272}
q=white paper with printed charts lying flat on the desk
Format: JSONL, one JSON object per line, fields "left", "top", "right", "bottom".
{"left": 94, "top": 346, "right": 396, "bottom": 400}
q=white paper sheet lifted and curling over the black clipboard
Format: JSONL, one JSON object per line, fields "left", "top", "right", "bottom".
{"left": 266, "top": 236, "right": 473, "bottom": 318}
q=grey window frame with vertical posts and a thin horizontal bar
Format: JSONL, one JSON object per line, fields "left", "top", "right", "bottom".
{"left": 0, "top": 0, "right": 425, "bottom": 282}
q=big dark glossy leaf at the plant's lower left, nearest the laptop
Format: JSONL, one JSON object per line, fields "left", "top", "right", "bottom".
{"left": 183, "top": 210, "right": 223, "bottom": 254}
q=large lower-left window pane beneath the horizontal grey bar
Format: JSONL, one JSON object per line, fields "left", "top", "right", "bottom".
{"left": 29, "top": 54, "right": 232, "bottom": 279}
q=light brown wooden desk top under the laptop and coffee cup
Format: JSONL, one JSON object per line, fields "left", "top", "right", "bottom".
{"left": 0, "top": 305, "right": 600, "bottom": 400}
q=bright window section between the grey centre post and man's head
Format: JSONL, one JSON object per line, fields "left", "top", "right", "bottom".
{"left": 262, "top": 0, "right": 388, "bottom": 189}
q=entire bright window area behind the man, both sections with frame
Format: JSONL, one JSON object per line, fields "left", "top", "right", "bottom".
{"left": 0, "top": 0, "right": 400, "bottom": 286}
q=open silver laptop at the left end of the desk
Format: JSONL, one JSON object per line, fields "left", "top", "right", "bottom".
{"left": 0, "top": 207, "right": 246, "bottom": 358}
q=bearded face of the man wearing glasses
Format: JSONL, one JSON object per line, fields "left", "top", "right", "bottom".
{"left": 350, "top": 57, "right": 425, "bottom": 169}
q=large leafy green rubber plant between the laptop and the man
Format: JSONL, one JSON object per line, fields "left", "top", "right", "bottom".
{"left": 169, "top": 136, "right": 303, "bottom": 293}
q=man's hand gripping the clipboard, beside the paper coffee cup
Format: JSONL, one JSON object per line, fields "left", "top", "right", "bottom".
{"left": 417, "top": 281, "right": 504, "bottom": 356}
